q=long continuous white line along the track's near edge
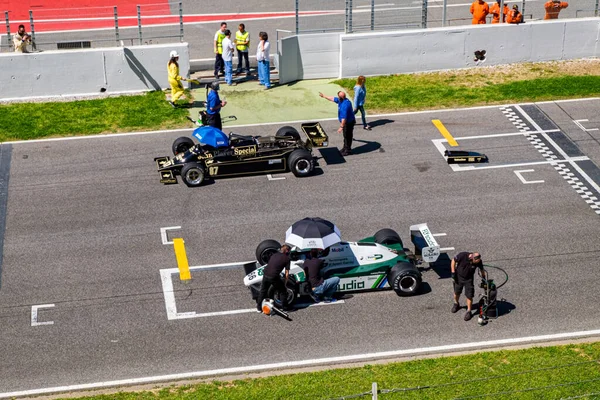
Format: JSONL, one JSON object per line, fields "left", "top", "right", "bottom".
{"left": 0, "top": 326, "right": 600, "bottom": 399}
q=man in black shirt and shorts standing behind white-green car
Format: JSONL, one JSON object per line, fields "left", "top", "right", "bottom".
{"left": 450, "top": 251, "right": 486, "bottom": 321}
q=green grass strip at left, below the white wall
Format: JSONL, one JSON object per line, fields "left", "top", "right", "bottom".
{"left": 0, "top": 91, "right": 189, "bottom": 142}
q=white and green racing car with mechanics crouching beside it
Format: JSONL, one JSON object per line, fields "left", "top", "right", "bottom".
{"left": 244, "top": 224, "right": 440, "bottom": 305}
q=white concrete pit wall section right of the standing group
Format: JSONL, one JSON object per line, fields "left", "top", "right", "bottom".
{"left": 277, "top": 18, "right": 600, "bottom": 83}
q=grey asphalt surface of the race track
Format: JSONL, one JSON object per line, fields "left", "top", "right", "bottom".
{"left": 0, "top": 99, "right": 600, "bottom": 397}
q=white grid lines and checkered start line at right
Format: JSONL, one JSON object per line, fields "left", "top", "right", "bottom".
{"left": 432, "top": 106, "right": 600, "bottom": 215}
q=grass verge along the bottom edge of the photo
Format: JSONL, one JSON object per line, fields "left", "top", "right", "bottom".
{"left": 57, "top": 342, "right": 600, "bottom": 400}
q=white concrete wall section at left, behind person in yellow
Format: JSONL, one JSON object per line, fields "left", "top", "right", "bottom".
{"left": 0, "top": 43, "right": 189, "bottom": 101}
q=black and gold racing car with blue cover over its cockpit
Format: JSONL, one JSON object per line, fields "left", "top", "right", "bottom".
{"left": 154, "top": 122, "right": 328, "bottom": 187}
